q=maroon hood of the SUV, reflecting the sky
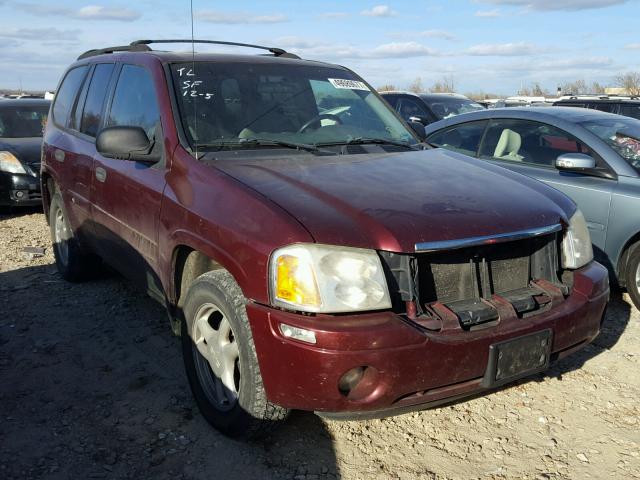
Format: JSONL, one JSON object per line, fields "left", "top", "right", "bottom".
{"left": 213, "top": 149, "right": 575, "bottom": 252}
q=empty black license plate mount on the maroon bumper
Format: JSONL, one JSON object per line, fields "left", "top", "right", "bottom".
{"left": 482, "top": 330, "right": 551, "bottom": 388}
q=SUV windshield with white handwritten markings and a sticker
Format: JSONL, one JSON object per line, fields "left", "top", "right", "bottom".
{"left": 171, "top": 62, "right": 416, "bottom": 150}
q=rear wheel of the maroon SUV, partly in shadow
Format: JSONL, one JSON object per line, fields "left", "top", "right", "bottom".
{"left": 49, "top": 191, "right": 100, "bottom": 282}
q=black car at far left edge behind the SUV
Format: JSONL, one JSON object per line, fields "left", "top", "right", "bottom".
{"left": 0, "top": 99, "right": 51, "bottom": 206}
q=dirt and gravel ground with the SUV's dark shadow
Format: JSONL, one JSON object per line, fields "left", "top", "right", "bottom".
{"left": 0, "top": 211, "right": 640, "bottom": 480}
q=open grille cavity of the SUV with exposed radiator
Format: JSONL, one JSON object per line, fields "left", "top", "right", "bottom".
{"left": 381, "top": 233, "right": 568, "bottom": 328}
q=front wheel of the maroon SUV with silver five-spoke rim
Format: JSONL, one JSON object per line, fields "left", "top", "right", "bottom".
{"left": 181, "top": 270, "right": 288, "bottom": 439}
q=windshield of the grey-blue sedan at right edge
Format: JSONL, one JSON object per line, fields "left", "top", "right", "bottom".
{"left": 580, "top": 117, "right": 640, "bottom": 173}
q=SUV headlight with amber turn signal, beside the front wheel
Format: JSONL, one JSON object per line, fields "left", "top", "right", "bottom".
{"left": 270, "top": 244, "right": 391, "bottom": 313}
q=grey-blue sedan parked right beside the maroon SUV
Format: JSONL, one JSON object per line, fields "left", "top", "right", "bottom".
{"left": 426, "top": 107, "right": 640, "bottom": 308}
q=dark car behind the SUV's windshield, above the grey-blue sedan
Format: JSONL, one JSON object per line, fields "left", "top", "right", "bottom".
{"left": 380, "top": 92, "right": 485, "bottom": 125}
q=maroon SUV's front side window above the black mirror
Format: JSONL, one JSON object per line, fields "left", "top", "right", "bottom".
{"left": 107, "top": 65, "right": 160, "bottom": 139}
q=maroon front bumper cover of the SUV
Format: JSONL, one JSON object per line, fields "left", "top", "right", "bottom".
{"left": 247, "top": 262, "right": 609, "bottom": 418}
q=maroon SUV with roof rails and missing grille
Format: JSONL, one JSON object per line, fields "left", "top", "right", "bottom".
{"left": 42, "top": 41, "right": 609, "bottom": 435}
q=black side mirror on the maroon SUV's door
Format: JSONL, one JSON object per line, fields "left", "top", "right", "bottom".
{"left": 96, "top": 127, "right": 158, "bottom": 163}
